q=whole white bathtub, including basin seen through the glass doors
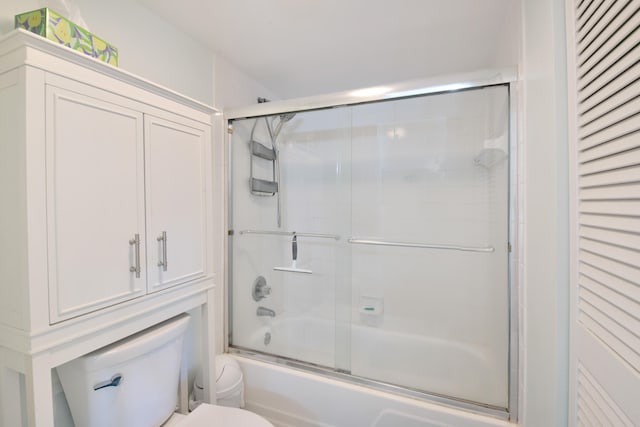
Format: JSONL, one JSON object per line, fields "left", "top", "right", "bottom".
{"left": 233, "top": 316, "right": 513, "bottom": 427}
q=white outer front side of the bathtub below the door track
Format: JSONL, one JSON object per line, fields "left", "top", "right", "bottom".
{"left": 233, "top": 355, "right": 513, "bottom": 427}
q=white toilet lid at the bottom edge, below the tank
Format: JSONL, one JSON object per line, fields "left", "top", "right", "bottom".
{"left": 176, "top": 403, "right": 273, "bottom": 427}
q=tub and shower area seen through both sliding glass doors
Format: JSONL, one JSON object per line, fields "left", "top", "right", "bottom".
{"left": 228, "top": 77, "right": 516, "bottom": 425}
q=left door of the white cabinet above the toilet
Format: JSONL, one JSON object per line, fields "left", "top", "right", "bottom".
{"left": 46, "top": 86, "right": 146, "bottom": 323}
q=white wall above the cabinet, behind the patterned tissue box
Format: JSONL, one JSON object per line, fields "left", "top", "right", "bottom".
{"left": 0, "top": 0, "right": 214, "bottom": 104}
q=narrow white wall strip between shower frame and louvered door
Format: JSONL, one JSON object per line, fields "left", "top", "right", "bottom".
{"left": 520, "top": 0, "right": 569, "bottom": 427}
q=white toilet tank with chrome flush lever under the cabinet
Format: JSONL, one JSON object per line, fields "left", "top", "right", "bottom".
{"left": 57, "top": 314, "right": 189, "bottom": 427}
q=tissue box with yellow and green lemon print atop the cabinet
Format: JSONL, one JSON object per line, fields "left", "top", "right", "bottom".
{"left": 15, "top": 8, "right": 118, "bottom": 66}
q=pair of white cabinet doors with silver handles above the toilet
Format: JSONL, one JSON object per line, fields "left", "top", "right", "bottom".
{"left": 45, "top": 77, "right": 211, "bottom": 323}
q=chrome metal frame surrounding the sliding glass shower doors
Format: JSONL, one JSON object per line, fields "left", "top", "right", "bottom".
{"left": 224, "top": 68, "right": 523, "bottom": 422}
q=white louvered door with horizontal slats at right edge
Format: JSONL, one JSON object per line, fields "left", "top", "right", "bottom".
{"left": 567, "top": 0, "right": 640, "bottom": 426}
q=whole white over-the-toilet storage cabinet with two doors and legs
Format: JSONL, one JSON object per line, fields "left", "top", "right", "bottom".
{"left": 0, "top": 30, "right": 222, "bottom": 427}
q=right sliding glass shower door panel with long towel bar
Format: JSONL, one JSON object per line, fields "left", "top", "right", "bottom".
{"left": 351, "top": 86, "right": 509, "bottom": 408}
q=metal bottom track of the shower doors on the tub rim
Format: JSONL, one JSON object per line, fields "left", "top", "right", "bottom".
{"left": 228, "top": 346, "right": 509, "bottom": 420}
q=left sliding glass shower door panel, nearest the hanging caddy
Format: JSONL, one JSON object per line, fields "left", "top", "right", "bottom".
{"left": 230, "top": 109, "right": 350, "bottom": 368}
